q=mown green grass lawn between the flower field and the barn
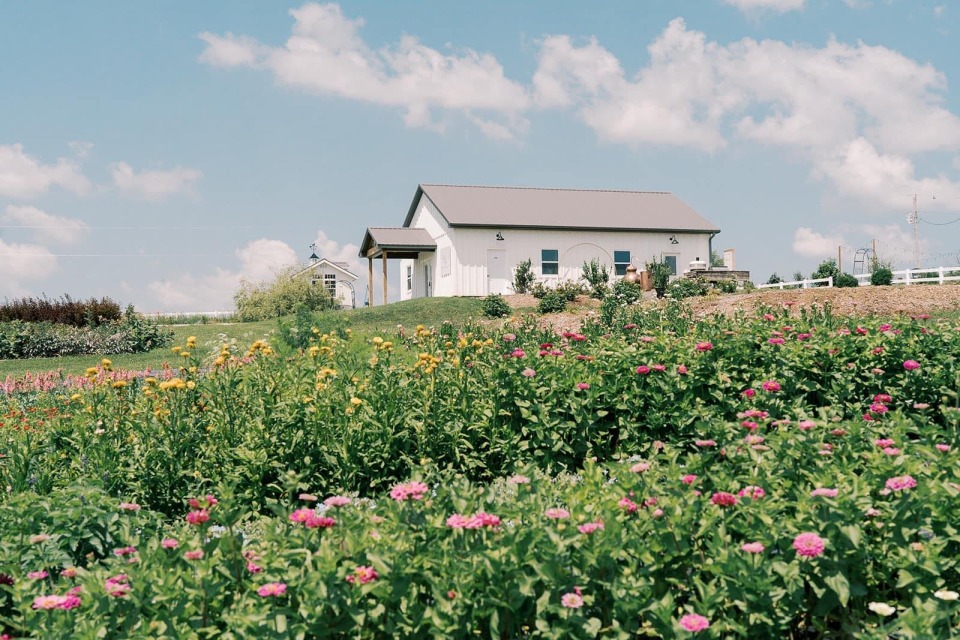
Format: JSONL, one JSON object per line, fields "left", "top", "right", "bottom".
{"left": 0, "top": 298, "right": 482, "bottom": 379}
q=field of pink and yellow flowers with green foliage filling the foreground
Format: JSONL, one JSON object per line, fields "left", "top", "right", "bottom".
{"left": 0, "top": 305, "right": 960, "bottom": 639}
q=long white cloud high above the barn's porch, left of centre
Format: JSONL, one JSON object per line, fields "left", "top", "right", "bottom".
{"left": 200, "top": 3, "right": 530, "bottom": 137}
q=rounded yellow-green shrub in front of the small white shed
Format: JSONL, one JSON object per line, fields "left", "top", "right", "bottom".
{"left": 233, "top": 267, "right": 337, "bottom": 322}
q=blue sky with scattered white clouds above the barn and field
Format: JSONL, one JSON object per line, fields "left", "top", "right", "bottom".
{"left": 0, "top": 0, "right": 960, "bottom": 311}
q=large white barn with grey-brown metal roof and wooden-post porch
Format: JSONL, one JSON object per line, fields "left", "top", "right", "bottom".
{"left": 360, "top": 184, "right": 720, "bottom": 303}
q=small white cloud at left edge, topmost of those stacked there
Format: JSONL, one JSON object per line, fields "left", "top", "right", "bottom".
{"left": 0, "top": 144, "right": 90, "bottom": 199}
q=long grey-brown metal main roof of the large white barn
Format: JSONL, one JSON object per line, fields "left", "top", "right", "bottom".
{"left": 403, "top": 184, "right": 720, "bottom": 233}
